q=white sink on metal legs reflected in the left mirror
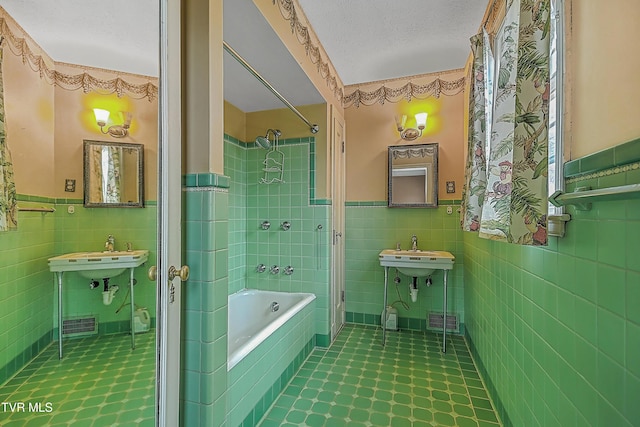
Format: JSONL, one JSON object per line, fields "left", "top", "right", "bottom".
{"left": 49, "top": 249, "right": 149, "bottom": 359}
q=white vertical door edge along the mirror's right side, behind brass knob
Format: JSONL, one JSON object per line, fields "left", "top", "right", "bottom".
{"left": 156, "top": 0, "right": 183, "bottom": 427}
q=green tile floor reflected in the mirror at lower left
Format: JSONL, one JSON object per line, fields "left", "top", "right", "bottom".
{"left": 0, "top": 331, "right": 156, "bottom": 427}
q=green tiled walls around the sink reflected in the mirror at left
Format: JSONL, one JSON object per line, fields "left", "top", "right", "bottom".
{"left": 0, "top": 195, "right": 156, "bottom": 383}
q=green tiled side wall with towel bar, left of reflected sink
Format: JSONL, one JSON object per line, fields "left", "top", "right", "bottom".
{"left": 0, "top": 196, "right": 55, "bottom": 384}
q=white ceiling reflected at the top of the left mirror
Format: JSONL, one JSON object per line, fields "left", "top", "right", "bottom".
{"left": 0, "top": 0, "right": 160, "bottom": 76}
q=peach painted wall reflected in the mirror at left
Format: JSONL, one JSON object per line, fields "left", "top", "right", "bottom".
{"left": 3, "top": 10, "right": 158, "bottom": 200}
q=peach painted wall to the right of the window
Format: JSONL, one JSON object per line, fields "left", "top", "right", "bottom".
{"left": 567, "top": 0, "right": 640, "bottom": 159}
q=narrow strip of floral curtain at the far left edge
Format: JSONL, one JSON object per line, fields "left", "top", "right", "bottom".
{"left": 0, "top": 49, "right": 18, "bottom": 231}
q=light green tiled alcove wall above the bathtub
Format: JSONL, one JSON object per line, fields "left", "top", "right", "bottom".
{"left": 225, "top": 136, "right": 331, "bottom": 334}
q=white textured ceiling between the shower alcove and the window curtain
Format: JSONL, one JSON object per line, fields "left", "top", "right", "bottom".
{"left": 298, "top": 0, "right": 488, "bottom": 85}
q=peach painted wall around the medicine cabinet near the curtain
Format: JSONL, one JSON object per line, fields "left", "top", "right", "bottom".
{"left": 345, "top": 71, "right": 467, "bottom": 202}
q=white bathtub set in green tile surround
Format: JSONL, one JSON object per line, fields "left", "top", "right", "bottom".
{"left": 227, "top": 289, "right": 316, "bottom": 371}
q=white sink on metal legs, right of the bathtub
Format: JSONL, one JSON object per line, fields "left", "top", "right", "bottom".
{"left": 378, "top": 249, "right": 455, "bottom": 353}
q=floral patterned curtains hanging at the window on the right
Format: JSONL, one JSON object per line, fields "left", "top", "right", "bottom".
{"left": 463, "top": 0, "right": 551, "bottom": 245}
